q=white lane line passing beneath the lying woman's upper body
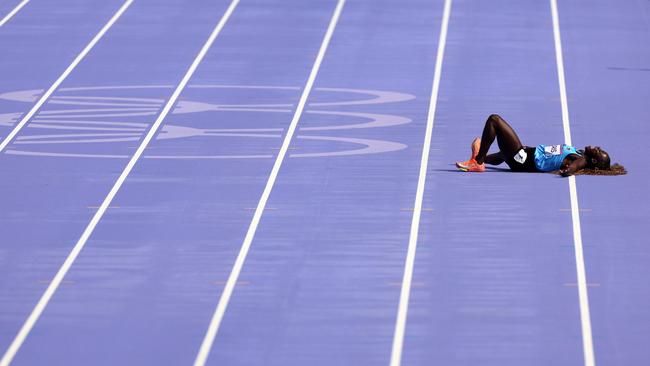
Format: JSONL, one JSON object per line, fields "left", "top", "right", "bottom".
{"left": 550, "top": 0, "right": 596, "bottom": 366}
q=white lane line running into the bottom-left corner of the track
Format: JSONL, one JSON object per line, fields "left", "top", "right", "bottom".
{"left": 0, "top": 0, "right": 239, "bottom": 366}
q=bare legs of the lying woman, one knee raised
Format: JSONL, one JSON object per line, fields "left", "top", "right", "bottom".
{"left": 476, "top": 114, "right": 523, "bottom": 165}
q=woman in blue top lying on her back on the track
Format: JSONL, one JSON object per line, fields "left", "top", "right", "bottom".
{"left": 456, "top": 114, "right": 627, "bottom": 177}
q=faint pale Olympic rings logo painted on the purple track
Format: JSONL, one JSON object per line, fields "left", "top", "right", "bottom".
{"left": 0, "top": 85, "right": 415, "bottom": 159}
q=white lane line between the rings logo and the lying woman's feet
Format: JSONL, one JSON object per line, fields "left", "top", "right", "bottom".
{"left": 390, "top": 0, "right": 451, "bottom": 366}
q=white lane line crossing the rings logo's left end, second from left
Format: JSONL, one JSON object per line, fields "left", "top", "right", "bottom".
{"left": 0, "top": 0, "right": 133, "bottom": 154}
